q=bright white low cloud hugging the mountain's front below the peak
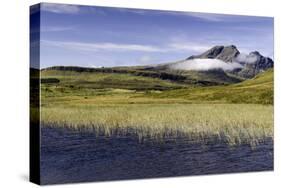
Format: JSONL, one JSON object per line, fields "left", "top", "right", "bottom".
{"left": 170, "top": 59, "right": 242, "bottom": 71}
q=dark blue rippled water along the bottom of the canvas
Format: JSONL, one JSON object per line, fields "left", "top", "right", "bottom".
{"left": 41, "top": 128, "right": 273, "bottom": 184}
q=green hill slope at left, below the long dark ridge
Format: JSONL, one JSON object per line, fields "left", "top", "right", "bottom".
{"left": 41, "top": 69, "right": 186, "bottom": 92}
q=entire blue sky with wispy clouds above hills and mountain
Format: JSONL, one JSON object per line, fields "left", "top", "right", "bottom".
{"left": 37, "top": 3, "right": 274, "bottom": 68}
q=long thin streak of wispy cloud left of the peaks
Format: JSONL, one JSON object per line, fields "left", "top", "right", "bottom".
{"left": 41, "top": 40, "right": 209, "bottom": 53}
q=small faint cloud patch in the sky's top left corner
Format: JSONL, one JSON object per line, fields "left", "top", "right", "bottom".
{"left": 41, "top": 3, "right": 80, "bottom": 14}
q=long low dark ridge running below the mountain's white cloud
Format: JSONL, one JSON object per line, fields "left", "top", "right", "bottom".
{"left": 41, "top": 62, "right": 242, "bottom": 86}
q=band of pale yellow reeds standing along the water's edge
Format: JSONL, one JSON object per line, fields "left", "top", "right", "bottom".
{"left": 41, "top": 104, "right": 273, "bottom": 145}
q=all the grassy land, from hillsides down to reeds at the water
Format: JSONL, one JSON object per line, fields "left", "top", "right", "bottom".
{"left": 38, "top": 67, "right": 273, "bottom": 145}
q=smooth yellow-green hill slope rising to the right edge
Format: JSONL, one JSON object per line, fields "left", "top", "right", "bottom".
{"left": 150, "top": 69, "right": 274, "bottom": 104}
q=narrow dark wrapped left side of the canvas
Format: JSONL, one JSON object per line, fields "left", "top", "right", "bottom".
{"left": 29, "top": 4, "right": 41, "bottom": 185}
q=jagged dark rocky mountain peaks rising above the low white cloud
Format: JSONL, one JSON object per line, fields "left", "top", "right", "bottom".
{"left": 186, "top": 45, "right": 274, "bottom": 78}
